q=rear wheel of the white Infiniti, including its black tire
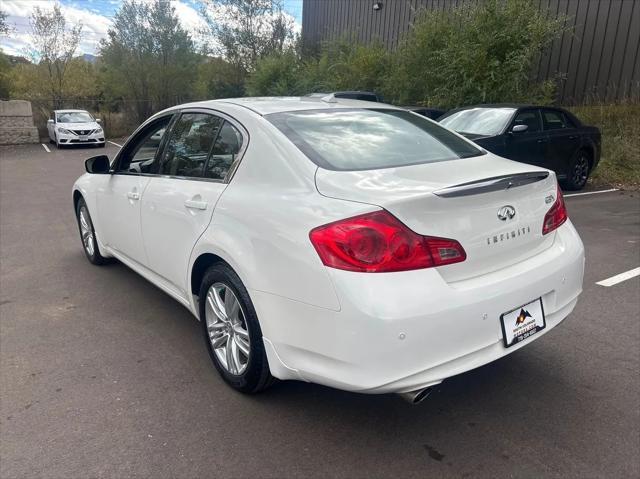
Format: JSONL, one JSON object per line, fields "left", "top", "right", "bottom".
{"left": 199, "top": 263, "right": 274, "bottom": 394}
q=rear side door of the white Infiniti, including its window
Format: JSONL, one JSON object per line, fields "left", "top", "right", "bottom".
{"left": 141, "top": 110, "right": 247, "bottom": 298}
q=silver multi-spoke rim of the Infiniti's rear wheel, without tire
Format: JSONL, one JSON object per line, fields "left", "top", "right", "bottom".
{"left": 205, "top": 283, "right": 251, "bottom": 375}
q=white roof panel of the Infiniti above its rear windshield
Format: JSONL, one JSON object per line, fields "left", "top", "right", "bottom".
{"left": 170, "top": 96, "right": 401, "bottom": 115}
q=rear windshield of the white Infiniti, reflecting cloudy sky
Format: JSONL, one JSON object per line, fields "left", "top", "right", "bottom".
{"left": 266, "top": 108, "right": 484, "bottom": 171}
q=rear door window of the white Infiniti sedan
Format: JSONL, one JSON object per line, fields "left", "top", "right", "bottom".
{"left": 158, "top": 113, "right": 223, "bottom": 178}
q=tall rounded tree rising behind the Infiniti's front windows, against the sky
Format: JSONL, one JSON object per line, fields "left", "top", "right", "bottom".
{"left": 100, "top": 0, "right": 198, "bottom": 122}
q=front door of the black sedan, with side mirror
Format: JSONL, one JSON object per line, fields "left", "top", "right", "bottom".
{"left": 505, "top": 108, "right": 549, "bottom": 166}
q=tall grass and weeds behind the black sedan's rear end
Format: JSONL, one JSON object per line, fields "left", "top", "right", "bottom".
{"left": 569, "top": 103, "right": 640, "bottom": 190}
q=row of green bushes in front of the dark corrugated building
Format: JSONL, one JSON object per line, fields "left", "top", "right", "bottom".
{"left": 247, "top": 0, "right": 564, "bottom": 108}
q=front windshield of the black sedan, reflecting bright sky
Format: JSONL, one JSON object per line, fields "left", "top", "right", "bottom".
{"left": 439, "top": 108, "right": 516, "bottom": 136}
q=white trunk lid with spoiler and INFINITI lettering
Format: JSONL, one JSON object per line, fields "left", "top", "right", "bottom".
{"left": 316, "top": 154, "right": 556, "bottom": 282}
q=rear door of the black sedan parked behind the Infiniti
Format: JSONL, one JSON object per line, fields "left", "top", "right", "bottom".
{"left": 542, "top": 108, "right": 580, "bottom": 178}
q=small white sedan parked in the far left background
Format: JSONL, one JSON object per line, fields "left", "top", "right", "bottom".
{"left": 47, "top": 110, "right": 104, "bottom": 148}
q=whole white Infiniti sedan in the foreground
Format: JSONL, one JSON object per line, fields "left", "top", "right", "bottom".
{"left": 73, "top": 97, "right": 584, "bottom": 403}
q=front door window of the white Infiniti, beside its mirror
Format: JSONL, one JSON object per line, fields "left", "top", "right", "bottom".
{"left": 118, "top": 116, "right": 171, "bottom": 173}
